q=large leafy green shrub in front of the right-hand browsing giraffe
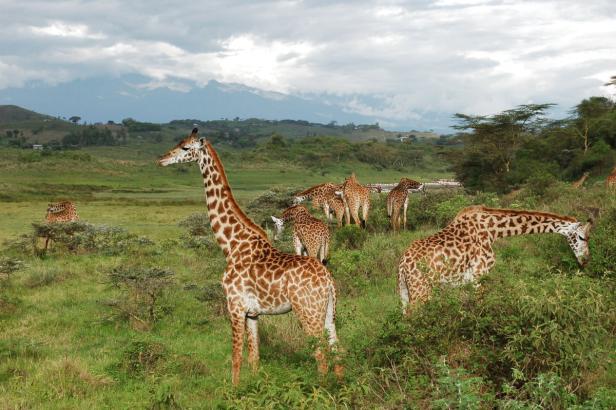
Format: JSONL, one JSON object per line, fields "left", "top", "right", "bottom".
{"left": 369, "top": 273, "right": 616, "bottom": 397}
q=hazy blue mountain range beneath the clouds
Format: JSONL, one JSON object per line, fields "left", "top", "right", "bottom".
{"left": 0, "top": 75, "right": 447, "bottom": 132}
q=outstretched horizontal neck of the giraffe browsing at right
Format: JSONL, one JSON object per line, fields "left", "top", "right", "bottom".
{"left": 480, "top": 209, "right": 579, "bottom": 240}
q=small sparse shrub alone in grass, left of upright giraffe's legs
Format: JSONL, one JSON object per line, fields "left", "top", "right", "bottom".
{"left": 109, "top": 267, "right": 173, "bottom": 330}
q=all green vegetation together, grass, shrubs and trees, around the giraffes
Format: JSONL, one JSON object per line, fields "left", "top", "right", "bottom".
{"left": 0, "top": 91, "right": 616, "bottom": 409}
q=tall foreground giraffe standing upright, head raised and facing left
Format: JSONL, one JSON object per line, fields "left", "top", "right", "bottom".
{"left": 158, "top": 128, "right": 343, "bottom": 385}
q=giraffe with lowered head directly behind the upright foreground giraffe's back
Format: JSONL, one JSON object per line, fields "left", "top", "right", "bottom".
{"left": 272, "top": 205, "right": 329, "bottom": 265}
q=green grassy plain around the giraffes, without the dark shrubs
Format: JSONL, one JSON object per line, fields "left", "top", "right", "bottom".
{"left": 0, "top": 143, "right": 616, "bottom": 409}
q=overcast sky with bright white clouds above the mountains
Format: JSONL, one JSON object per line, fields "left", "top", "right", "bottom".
{"left": 0, "top": 0, "right": 616, "bottom": 128}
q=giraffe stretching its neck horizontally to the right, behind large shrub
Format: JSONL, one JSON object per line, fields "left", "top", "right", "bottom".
{"left": 398, "top": 205, "right": 593, "bottom": 309}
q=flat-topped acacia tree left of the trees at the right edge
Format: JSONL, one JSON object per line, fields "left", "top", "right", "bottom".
{"left": 454, "top": 104, "right": 554, "bottom": 191}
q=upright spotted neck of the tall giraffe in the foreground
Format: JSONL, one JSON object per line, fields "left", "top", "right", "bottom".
{"left": 198, "top": 142, "right": 268, "bottom": 261}
